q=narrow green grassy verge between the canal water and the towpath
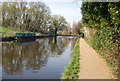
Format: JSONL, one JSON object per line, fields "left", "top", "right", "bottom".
{"left": 62, "top": 39, "right": 80, "bottom": 81}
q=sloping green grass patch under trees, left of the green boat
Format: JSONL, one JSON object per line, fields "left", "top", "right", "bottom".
{"left": 0, "top": 26, "right": 21, "bottom": 37}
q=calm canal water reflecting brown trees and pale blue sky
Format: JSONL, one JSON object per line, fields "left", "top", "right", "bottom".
{"left": 2, "top": 36, "right": 77, "bottom": 79}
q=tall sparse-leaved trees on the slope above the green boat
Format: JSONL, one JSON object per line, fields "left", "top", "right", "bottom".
{"left": 0, "top": 1, "right": 50, "bottom": 32}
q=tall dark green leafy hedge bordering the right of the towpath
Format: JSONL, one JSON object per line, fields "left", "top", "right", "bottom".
{"left": 81, "top": 2, "right": 120, "bottom": 78}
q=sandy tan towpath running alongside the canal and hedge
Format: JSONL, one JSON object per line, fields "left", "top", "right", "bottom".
{"left": 78, "top": 38, "right": 116, "bottom": 79}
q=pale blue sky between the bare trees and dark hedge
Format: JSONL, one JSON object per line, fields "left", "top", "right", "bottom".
{"left": 42, "top": 0, "right": 82, "bottom": 23}
